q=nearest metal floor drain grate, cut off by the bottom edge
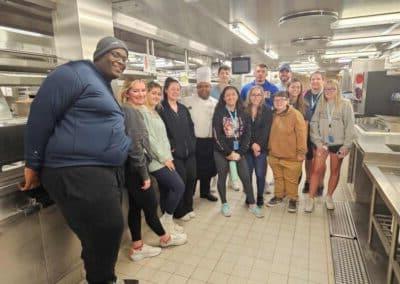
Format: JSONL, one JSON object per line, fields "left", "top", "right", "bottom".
{"left": 331, "top": 237, "right": 369, "bottom": 284}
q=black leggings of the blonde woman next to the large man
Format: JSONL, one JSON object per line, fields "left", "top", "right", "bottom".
{"left": 126, "top": 173, "right": 165, "bottom": 241}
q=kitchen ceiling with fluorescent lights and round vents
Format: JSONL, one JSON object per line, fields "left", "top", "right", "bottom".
{"left": 113, "top": 0, "right": 400, "bottom": 69}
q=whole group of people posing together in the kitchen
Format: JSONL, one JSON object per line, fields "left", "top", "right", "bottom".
{"left": 22, "top": 37, "right": 354, "bottom": 283}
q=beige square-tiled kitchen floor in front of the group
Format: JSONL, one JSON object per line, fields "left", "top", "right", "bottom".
{"left": 117, "top": 164, "right": 334, "bottom": 284}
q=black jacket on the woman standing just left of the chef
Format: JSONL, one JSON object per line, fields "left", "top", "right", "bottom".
{"left": 159, "top": 100, "right": 196, "bottom": 159}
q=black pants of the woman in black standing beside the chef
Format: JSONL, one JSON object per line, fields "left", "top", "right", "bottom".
{"left": 174, "top": 155, "right": 196, "bottom": 218}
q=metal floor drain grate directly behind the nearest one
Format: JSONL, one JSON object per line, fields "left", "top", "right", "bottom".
{"left": 328, "top": 202, "right": 357, "bottom": 239}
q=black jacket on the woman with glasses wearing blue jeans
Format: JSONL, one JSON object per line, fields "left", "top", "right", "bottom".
{"left": 249, "top": 105, "right": 272, "bottom": 152}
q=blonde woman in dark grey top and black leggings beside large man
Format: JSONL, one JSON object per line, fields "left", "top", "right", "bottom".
{"left": 121, "top": 80, "right": 186, "bottom": 261}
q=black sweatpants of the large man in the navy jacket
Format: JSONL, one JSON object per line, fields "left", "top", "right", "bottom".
{"left": 41, "top": 166, "right": 124, "bottom": 284}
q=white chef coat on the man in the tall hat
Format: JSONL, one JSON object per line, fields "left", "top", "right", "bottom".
{"left": 182, "top": 94, "right": 218, "bottom": 138}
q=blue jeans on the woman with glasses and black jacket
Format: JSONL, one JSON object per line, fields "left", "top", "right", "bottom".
{"left": 246, "top": 151, "right": 267, "bottom": 205}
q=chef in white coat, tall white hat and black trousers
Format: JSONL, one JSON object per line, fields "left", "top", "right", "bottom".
{"left": 182, "top": 66, "right": 218, "bottom": 202}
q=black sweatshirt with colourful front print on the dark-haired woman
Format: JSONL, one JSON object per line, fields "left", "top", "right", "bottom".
{"left": 212, "top": 106, "right": 251, "bottom": 156}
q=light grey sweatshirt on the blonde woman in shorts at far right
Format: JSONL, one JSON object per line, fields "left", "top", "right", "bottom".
{"left": 310, "top": 98, "right": 356, "bottom": 148}
